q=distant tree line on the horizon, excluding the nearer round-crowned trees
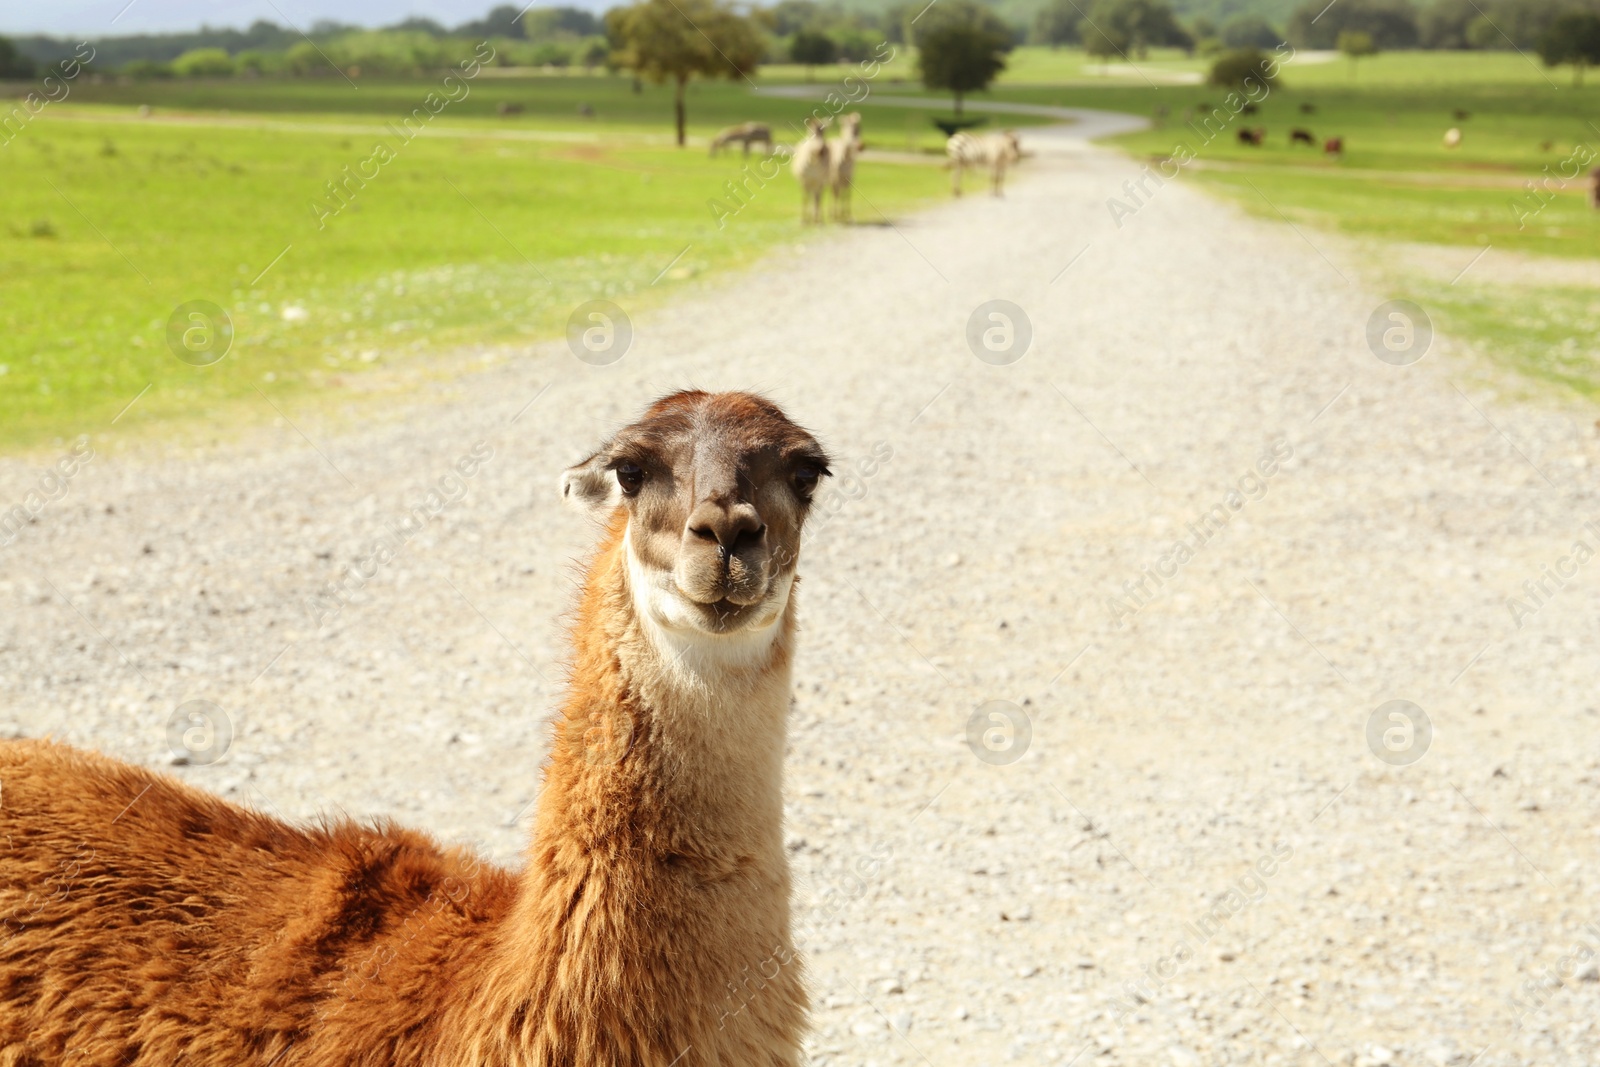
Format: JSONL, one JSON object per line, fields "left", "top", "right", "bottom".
{"left": 0, "top": 0, "right": 1600, "bottom": 78}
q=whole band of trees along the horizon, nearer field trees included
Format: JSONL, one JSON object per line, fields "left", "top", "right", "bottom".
{"left": 9, "top": 0, "right": 1600, "bottom": 146}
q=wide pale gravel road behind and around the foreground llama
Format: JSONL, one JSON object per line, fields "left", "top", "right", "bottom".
{"left": 0, "top": 116, "right": 1600, "bottom": 1067}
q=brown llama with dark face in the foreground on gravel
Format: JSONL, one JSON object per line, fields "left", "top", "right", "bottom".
{"left": 0, "top": 392, "right": 829, "bottom": 1067}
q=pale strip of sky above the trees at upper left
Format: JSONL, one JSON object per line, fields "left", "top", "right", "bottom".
{"left": 0, "top": 0, "right": 611, "bottom": 37}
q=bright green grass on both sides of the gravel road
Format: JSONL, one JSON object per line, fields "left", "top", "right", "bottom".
{"left": 0, "top": 48, "right": 1600, "bottom": 448}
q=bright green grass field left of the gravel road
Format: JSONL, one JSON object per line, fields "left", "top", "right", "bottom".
{"left": 0, "top": 78, "right": 946, "bottom": 446}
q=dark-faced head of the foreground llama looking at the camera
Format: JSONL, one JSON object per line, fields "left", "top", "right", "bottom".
{"left": 562, "top": 390, "right": 829, "bottom": 637}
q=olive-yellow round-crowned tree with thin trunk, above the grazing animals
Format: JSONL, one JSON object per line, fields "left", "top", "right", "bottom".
{"left": 605, "top": 0, "right": 766, "bottom": 149}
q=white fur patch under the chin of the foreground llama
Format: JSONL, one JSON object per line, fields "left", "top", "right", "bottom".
{"left": 622, "top": 531, "right": 794, "bottom": 681}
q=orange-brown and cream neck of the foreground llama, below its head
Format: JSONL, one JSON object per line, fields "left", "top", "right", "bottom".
{"left": 459, "top": 522, "right": 805, "bottom": 1064}
